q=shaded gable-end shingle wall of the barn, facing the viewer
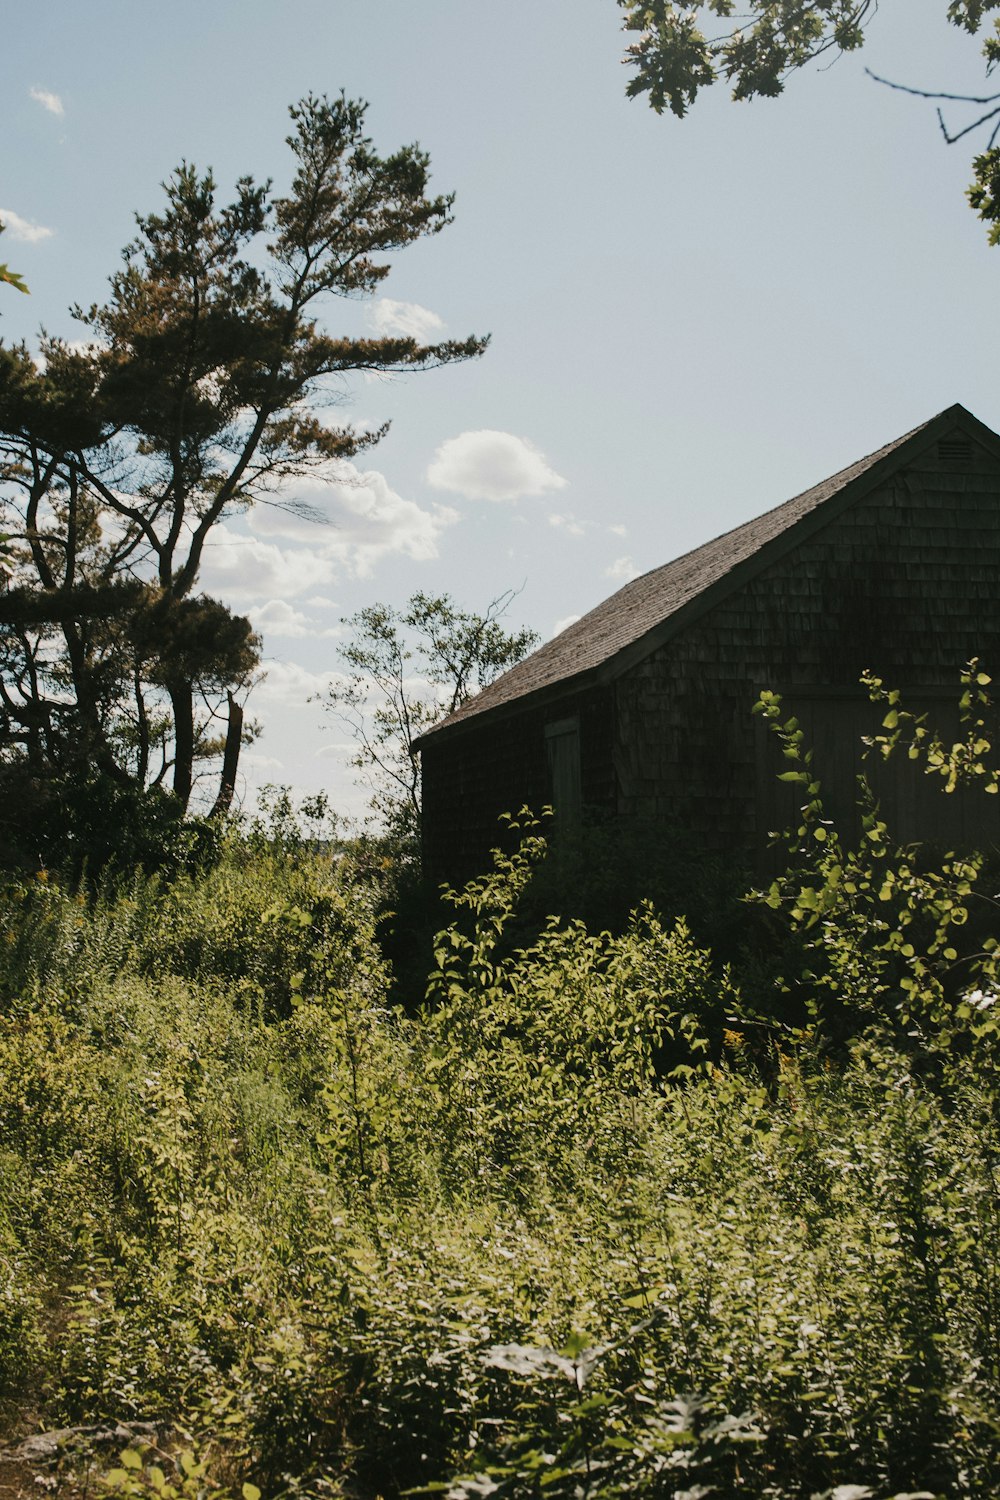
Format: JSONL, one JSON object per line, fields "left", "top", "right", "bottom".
{"left": 615, "top": 447, "right": 1000, "bottom": 846}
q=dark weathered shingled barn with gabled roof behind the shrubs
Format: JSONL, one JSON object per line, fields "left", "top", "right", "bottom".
{"left": 418, "top": 407, "right": 1000, "bottom": 879}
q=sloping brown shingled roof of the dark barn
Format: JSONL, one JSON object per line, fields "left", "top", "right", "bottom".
{"left": 417, "top": 405, "right": 1000, "bottom": 749}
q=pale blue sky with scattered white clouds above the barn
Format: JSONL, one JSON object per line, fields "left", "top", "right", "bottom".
{"left": 0, "top": 0, "right": 1000, "bottom": 813}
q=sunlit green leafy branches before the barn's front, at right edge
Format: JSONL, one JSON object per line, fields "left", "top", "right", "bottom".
{"left": 756, "top": 660, "right": 1000, "bottom": 1074}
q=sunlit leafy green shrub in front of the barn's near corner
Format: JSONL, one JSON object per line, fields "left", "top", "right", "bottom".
{"left": 420, "top": 825, "right": 736, "bottom": 1187}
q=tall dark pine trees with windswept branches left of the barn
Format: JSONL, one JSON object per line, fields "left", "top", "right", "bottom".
{"left": 0, "top": 95, "right": 489, "bottom": 867}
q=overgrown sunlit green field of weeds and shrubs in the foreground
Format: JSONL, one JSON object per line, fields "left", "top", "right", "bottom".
{"left": 0, "top": 816, "right": 1000, "bottom": 1500}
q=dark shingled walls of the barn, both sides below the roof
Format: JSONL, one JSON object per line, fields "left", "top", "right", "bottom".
{"left": 423, "top": 443, "right": 1000, "bottom": 881}
